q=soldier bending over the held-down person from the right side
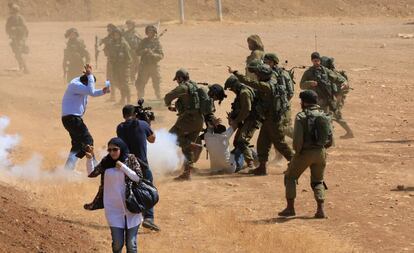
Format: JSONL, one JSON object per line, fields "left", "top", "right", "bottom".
{"left": 224, "top": 76, "right": 261, "bottom": 169}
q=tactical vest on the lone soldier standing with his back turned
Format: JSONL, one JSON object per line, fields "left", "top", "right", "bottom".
{"left": 301, "top": 107, "right": 333, "bottom": 148}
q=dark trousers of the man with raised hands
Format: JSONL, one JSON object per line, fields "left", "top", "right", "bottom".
{"left": 62, "top": 115, "right": 93, "bottom": 158}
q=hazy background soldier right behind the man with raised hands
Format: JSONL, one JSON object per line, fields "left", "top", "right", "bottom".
{"left": 63, "top": 28, "right": 90, "bottom": 82}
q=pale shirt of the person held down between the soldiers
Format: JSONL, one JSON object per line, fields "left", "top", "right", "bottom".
{"left": 204, "top": 127, "right": 236, "bottom": 173}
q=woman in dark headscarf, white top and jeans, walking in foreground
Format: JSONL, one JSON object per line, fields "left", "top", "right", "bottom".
{"left": 86, "top": 138, "right": 142, "bottom": 253}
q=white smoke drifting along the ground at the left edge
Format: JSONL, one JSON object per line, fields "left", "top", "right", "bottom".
{"left": 0, "top": 117, "right": 86, "bottom": 181}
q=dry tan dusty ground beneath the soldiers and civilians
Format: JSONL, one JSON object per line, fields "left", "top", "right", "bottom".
{"left": 0, "top": 18, "right": 414, "bottom": 252}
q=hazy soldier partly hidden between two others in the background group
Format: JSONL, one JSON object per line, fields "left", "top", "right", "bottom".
{"left": 124, "top": 20, "right": 142, "bottom": 82}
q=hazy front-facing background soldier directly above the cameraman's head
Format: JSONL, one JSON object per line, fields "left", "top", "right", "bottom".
{"left": 108, "top": 29, "right": 132, "bottom": 105}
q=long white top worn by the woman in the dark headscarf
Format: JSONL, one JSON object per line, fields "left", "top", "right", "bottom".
{"left": 86, "top": 159, "right": 143, "bottom": 229}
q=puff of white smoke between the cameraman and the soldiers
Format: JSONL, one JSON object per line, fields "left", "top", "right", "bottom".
{"left": 147, "top": 129, "right": 183, "bottom": 174}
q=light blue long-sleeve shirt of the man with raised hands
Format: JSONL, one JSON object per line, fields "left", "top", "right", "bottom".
{"left": 62, "top": 74, "right": 104, "bottom": 117}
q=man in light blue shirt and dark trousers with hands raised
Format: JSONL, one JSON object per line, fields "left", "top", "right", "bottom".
{"left": 62, "top": 64, "right": 110, "bottom": 170}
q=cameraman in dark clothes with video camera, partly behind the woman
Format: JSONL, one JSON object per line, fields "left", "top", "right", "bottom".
{"left": 84, "top": 99, "right": 160, "bottom": 231}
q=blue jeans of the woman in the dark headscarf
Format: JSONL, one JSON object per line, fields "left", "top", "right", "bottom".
{"left": 110, "top": 225, "right": 139, "bottom": 253}
